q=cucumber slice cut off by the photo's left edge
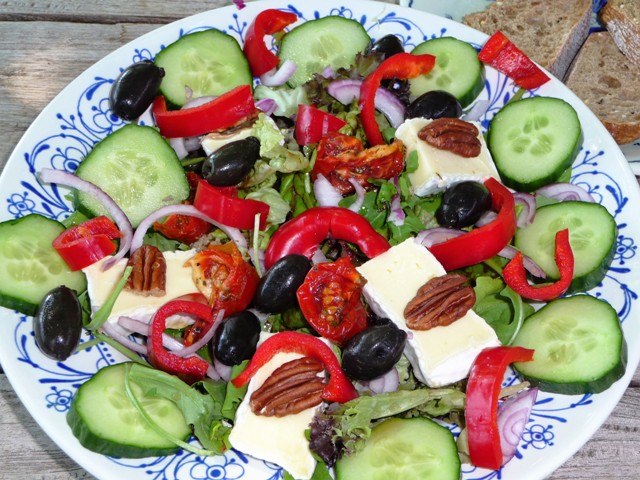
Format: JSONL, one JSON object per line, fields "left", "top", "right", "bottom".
{"left": 0, "top": 214, "right": 87, "bottom": 316}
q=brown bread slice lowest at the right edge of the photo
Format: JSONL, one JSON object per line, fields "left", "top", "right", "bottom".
{"left": 565, "top": 32, "right": 640, "bottom": 145}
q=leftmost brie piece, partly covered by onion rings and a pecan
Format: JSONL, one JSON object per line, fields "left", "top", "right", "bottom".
{"left": 83, "top": 250, "right": 198, "bottom": 334}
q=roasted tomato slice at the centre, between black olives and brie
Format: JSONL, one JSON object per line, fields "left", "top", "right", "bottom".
{"left": 297, "top": 257, "right": 367, "bottom": 345}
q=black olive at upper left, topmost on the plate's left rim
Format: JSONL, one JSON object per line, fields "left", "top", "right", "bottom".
{"left": 109, "top": 60, "right": 164, "bottom": 121}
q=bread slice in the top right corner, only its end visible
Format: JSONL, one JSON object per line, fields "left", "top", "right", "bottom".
{"left": 600, "top": 0, "right": 640, "bottom": 67}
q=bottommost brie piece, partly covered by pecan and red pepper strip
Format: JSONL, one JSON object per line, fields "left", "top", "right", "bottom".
{"left": 229, "top": 333, "right": 322, "bottom": 480}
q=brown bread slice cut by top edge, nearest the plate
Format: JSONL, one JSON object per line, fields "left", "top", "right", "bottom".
{"left": 464, "top": 0, "right": 592, "bottom": 80}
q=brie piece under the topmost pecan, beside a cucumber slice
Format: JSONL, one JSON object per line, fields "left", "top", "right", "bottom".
{"left": 396, "top": 118, "right": 500, "bottom": 197}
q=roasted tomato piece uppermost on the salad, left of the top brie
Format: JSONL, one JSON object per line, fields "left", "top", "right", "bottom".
{"left": 311, "top": 133, "right": 404, "bottom": 195}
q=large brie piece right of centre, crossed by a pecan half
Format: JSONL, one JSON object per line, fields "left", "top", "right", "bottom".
{"left": 357, "top": 238, "right": 500, "bottom": 387}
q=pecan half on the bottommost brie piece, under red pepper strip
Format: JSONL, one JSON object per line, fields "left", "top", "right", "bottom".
{"left": 249, "top": 357, "right": 324, "bottom": 417}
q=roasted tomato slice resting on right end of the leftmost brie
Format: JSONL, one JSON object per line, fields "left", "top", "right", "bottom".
{"left": 186, "top": 242, "right": 260, "bottom": 317}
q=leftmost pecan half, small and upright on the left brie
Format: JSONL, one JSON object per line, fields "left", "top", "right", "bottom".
{"left": 124, "top": 245, "right": 167, "bottom": 297}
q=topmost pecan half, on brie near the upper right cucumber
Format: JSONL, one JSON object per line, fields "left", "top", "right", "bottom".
{"left": 418, "top": 117, "right": 482, "bottom": 158}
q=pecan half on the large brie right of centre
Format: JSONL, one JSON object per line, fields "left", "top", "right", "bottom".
{"left": 404, "top": 273, "right": 476, "bottom": 330}
